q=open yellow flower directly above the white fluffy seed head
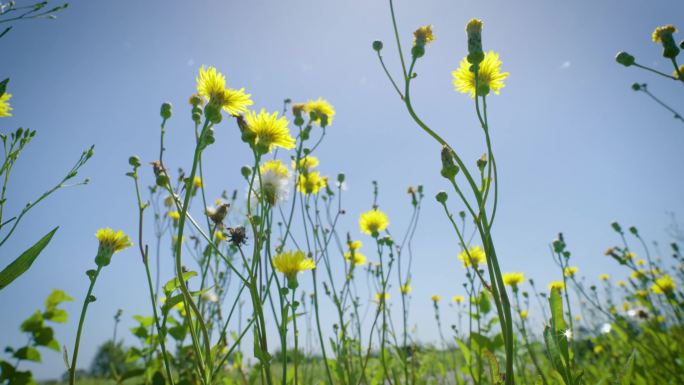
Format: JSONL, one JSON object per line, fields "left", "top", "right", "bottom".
{"left": 245, "top": 108, "right": 295, "bottom": 151}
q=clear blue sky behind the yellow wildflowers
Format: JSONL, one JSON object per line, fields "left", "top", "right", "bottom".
{"left": 0, "top": 0, "right": 684, "bottom": 378}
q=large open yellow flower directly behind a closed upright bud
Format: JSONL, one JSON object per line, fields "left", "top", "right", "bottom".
{"left": 452, "top": 51, "right": 509, "bottom": 98}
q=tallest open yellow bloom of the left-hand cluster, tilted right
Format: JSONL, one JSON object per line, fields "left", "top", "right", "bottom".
{"left": 197, "top": 66, "right": 252, "bottom": 115}
